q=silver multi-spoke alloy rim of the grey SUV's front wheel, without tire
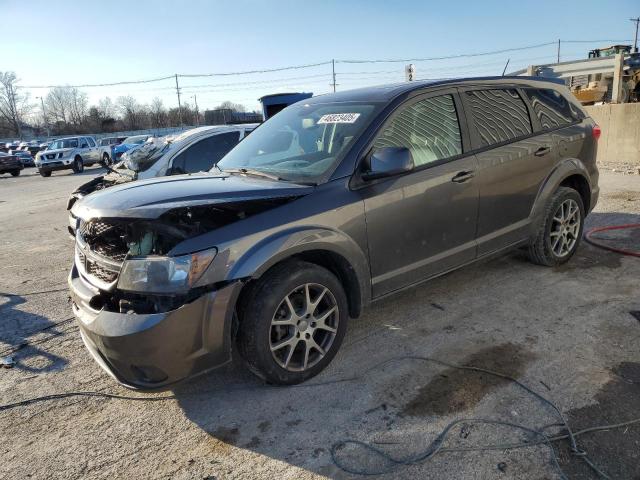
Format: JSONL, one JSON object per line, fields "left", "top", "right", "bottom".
{"left": 270, "top": 283, "right": 340, "bottom": 372}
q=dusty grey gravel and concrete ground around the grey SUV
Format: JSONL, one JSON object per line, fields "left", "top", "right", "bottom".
{"left": 0, "top": 168, "right": 640, "bottom": 479}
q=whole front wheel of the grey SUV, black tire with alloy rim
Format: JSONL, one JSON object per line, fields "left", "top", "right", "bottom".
{"left": 238, "top": 260, "right": 349, "bottom": 385}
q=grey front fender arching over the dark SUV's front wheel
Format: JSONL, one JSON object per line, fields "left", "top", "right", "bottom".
{"left": 198, "top": 226, "right": 371, "bottom": 305}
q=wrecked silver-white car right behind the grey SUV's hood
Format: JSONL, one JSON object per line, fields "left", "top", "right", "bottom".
{"left": 67, "top": 124, "right": 257, "bottom": 230}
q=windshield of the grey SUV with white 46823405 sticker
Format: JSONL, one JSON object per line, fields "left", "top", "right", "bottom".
{"left": 217, "top": 103, "right": 381, "bottom": 183}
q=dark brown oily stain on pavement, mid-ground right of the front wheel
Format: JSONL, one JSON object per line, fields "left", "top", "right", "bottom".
{"left": 401, "top": 343, "right": 535, "bottom": 416}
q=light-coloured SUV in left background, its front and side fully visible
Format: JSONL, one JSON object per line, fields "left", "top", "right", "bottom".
{"left": 36, "top": 137, "right": 100, "bottom": 177}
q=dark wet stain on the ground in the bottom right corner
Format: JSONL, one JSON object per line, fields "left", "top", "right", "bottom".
{"left": 558, "top": 362, "right": 640, "bottom": 480}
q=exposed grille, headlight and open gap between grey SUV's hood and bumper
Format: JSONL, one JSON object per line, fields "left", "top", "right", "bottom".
{"left": 75, "top": 198, "right": 287, "bottom": 314}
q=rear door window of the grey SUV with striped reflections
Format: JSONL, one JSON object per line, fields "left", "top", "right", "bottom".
{"left": 466, "top": 89, "right": 533, "bottom": 147}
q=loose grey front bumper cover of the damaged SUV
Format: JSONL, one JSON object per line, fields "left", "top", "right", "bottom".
{"left": 68, "top": 265, "right": 241, "bottom": 391}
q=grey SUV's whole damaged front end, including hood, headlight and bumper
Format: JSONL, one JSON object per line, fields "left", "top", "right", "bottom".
{"left": 68, "top": 174, "right": 311, "bottom": 390}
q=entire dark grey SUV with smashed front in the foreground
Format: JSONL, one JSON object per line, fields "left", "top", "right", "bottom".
{"left": 69, "top": 77, "right": 600, "bottom": 389}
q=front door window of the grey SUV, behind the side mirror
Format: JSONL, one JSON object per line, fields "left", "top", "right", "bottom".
{"left": 373, "top": 95, "right": 462, "bottom": 166}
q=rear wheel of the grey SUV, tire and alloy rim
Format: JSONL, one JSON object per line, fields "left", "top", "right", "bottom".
{"left": 528, "top": 187, "right": 585, "bottom": 267}
